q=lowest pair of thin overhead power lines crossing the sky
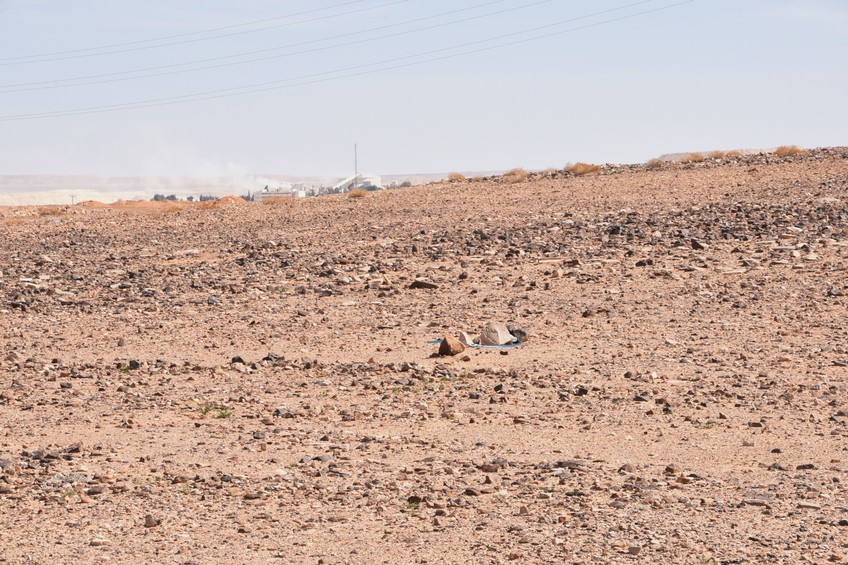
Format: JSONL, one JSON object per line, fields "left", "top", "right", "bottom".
{"left": 0, "top": 0, "right": 696, "bottom": 122}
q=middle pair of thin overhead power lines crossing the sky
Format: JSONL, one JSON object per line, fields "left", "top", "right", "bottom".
{"left": 0, "top": 0, "right": 568, "bottom": 94}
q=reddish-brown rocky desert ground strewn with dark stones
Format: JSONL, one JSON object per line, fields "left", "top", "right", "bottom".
{"left": 0, "top": 148, "right": 848, "bottom": 565}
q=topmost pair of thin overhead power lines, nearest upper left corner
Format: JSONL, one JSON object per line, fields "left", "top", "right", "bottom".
{"left": 0, "top": 0, "right": 410, "bottom": 66}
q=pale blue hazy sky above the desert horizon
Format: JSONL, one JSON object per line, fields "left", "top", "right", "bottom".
{"left": 0, "top": 0, "right": 848, "bottom": 176}
